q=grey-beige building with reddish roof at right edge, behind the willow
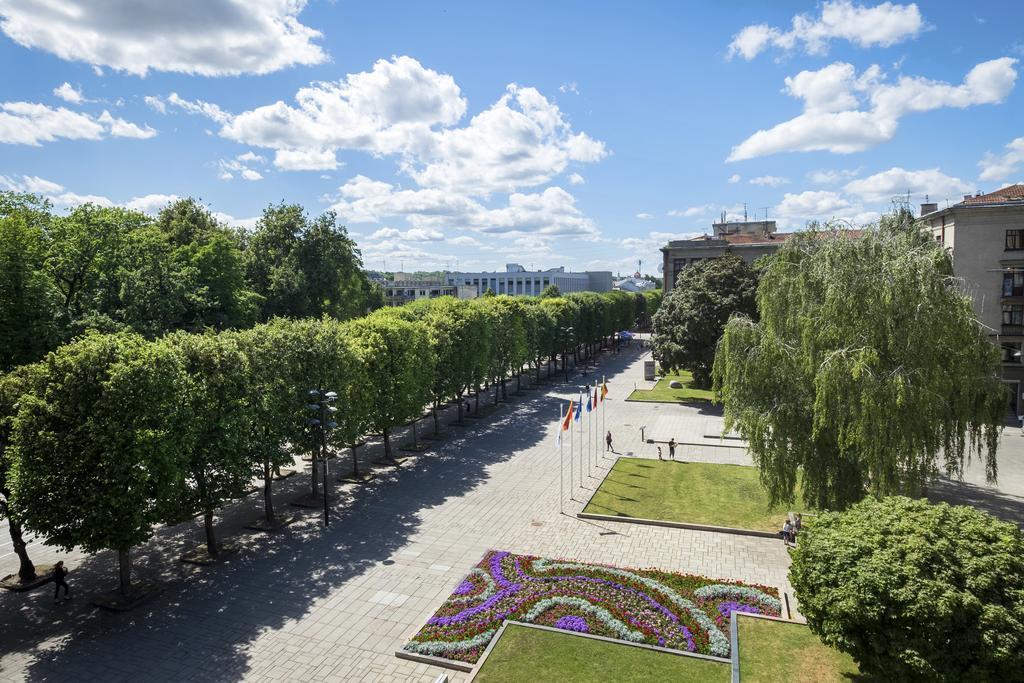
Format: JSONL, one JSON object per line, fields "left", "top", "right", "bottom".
{"left": 921, "top": 184, "right": 1024, "bottom": 417}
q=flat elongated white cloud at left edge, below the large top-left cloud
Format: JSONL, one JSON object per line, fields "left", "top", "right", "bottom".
{"left": 0, "top": 102, "right": 157, "bottom": 146}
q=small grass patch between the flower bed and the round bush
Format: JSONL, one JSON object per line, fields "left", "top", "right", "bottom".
{"left": 736, "top": 615, "right": 859, "bottom": 683}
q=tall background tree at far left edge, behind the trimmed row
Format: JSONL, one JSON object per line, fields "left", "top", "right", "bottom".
{"left": 0, "top": 194, "right": 60, "bottom": 372}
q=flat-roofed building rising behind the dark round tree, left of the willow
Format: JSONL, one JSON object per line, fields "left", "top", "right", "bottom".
{"left": 662, "top": 220, "right": 793, "bottom": 294}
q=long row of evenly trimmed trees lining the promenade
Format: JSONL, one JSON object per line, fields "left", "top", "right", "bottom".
{"left": 0, "top": 292, "right": 658, "bottom": 591}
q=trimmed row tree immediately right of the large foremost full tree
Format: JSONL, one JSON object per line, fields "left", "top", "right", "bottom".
{"left": 158, "top": 333, "right": 253, "bottom": 557}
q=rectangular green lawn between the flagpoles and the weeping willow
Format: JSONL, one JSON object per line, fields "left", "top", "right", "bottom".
{"left": 584, "top": 458, "right": 799, "bottom": 531}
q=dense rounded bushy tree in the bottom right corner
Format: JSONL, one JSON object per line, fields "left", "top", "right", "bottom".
{"left": 790, "top": 497, "right": 1024, "bottom": 683}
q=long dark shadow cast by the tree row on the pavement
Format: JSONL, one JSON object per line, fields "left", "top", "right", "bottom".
{"left": 0, "top": 353, "right": 635, "bottom": 681}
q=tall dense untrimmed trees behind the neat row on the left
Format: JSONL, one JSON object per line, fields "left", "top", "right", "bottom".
{"left": 0, "top": 193, "right": 383, "bottom": 372}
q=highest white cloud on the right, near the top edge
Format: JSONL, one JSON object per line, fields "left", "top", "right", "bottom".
{"left": 728, "top": 0, "right": 925, "bottom": 59}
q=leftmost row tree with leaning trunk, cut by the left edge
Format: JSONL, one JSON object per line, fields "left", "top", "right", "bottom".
{"left": 0, "top": 364, "right": 43, "bottom": 582}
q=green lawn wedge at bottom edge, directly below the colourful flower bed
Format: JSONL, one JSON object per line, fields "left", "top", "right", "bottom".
{"left": 473, "top": 626, "right": 731, "bottom": 683}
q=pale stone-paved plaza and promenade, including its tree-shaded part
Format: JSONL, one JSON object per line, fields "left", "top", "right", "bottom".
{"left": 0, "top": 349, "right": 1024, "bottom": 681}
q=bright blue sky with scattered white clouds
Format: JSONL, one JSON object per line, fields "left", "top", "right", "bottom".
{"left": 0, "top": 0, "right": 1024, "bottom": 272}
